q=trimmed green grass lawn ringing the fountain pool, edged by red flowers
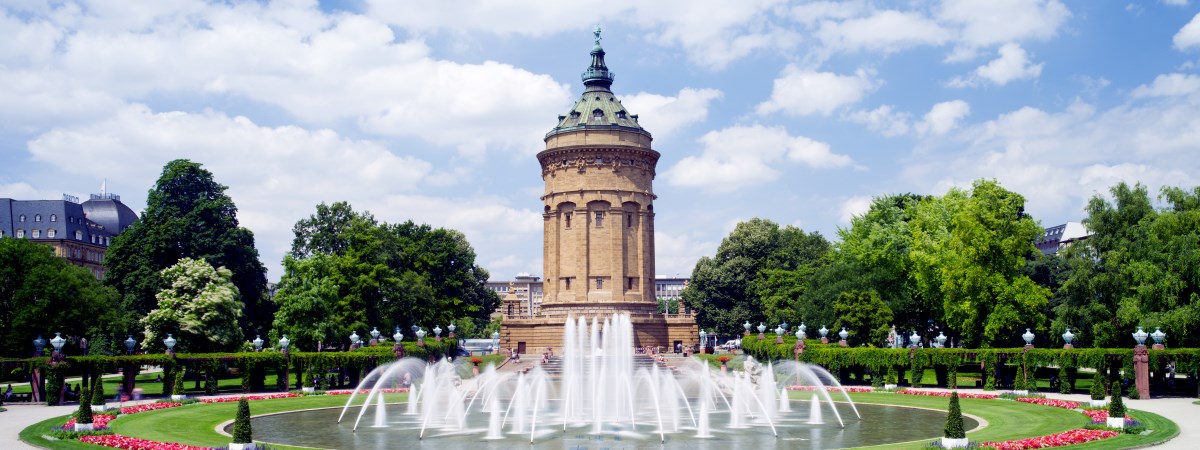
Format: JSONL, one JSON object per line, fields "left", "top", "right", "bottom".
{"left": 20, "top": 391, "right": 1178, "bottom": 449}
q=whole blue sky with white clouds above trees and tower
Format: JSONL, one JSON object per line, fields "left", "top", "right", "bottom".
{"left": 0, "top": 0, "right": 1200, "bottom": 280}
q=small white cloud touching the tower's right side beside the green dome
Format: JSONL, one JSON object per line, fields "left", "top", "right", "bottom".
{"left": 620, "top": 88, "right": 722, "bottom": 138}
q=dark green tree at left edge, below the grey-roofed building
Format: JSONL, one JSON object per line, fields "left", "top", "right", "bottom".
{"left": 0, "top": 239, "right": 130, "bottom": 356}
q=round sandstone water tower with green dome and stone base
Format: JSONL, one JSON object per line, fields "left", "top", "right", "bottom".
{"left": 500, "top": 29, "right": 697, "bottom": 353}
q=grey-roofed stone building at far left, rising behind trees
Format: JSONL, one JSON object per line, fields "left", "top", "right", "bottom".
{"left": 0, "top": 193, "right": 138, "bottom": 278}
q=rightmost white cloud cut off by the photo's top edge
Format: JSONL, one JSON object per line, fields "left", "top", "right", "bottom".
{"left": 937, "top": 0, "right": 1070, "bottom": 61}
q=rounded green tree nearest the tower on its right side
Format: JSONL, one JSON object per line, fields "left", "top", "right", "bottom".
{"left": 683, "top": 218, "right": 830, "bottom": 334}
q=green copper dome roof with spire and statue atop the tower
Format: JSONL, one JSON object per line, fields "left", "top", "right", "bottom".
{"left": 546, "top": 26, "right": 650, "bottom": 137}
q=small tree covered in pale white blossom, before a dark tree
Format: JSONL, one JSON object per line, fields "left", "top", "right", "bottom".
{"left": 142, "top": 258, "right": 242, "bottom": 353}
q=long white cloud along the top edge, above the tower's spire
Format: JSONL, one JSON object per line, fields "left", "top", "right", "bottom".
{"left": 367, "top": 0, "right": 799, "bottom": 68}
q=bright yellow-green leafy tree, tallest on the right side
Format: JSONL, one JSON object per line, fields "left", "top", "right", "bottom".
{"left": 910, "top": 180, "right": 1050, "bottom": 347}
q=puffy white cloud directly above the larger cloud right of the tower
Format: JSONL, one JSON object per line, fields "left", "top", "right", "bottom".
{"left": 756, "top": 65, "right": 880, "bottom": 115}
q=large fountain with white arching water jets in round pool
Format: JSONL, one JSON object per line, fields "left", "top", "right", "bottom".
{"left": 248, "top": 314, "right": 969, "bottom": 449}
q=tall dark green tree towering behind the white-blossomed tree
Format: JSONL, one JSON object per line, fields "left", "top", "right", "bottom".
{"left": 104, "top": 160, "right": 275, "bottom": 334}
